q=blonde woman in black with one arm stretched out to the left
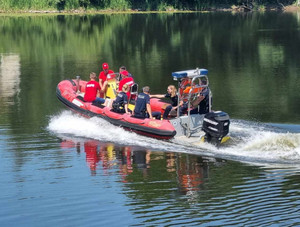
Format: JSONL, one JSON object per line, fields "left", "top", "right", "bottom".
{"left": 150, "top": 85, "right": 178, "bottom": 119}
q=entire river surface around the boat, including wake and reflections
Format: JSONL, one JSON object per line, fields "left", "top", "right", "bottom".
{"left": 0, "top": 12, "right": 300, "bottom": 226}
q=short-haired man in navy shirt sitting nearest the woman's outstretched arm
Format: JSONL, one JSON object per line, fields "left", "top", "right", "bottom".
{"left": 133, "top": 86, "right": 161, "bottom": 119}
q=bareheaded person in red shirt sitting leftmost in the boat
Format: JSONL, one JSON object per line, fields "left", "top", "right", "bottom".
{"left": 83, "top": 72, "right": 105, "bottom": 104}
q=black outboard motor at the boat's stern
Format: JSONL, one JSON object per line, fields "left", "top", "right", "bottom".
{"left": 202, "top": 111, "right": 230, "bottom": 145}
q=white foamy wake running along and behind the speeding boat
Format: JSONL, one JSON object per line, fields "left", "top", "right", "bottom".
{"left": 48, "top": 111, "right": 300, "bottom": 164}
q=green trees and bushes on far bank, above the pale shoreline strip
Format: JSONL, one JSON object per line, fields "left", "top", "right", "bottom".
{"left": 0, "top": 0, "right": 300, "bottom": 11}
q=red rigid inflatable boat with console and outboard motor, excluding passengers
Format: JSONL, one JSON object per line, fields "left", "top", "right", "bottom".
{"left": 56, "top": 68, "right": 230, "bottom": 145}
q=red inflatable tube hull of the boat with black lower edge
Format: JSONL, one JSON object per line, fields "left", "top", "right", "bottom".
{"left": 56, "top": 79, "right": 176, "bottom": 139}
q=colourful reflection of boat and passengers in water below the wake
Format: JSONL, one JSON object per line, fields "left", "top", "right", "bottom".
{"left": 61, "top": 138, "right": 225, "bottom": 196}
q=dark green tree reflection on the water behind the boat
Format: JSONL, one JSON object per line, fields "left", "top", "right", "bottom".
{"left": 0, "top": 13, "right": 300, "bottom": 133}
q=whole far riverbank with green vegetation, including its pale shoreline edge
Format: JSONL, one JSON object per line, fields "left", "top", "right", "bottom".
{"left": 0, "top": 0, "right": 300, "bottom": 14}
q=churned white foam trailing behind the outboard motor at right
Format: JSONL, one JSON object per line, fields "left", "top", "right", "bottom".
{"left": 220, "top": 121, "right": 300, "bottom": 162}
